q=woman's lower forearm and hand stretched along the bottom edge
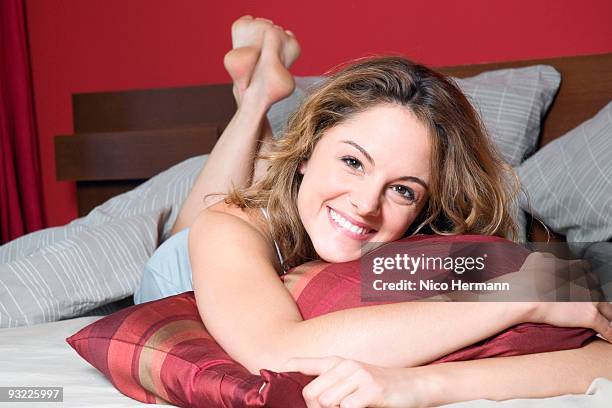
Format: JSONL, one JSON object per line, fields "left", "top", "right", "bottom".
{"left": 283, "top": 340, "right": 612, "bottom": 408}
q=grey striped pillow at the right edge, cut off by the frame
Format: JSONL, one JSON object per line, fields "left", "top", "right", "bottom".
{"left": 518, "top": 102, "right": 612, "bottom": 249}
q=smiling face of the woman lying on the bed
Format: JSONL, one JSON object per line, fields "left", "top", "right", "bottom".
{"left": 297, "top": 104, "right": 430, "bottom": 262}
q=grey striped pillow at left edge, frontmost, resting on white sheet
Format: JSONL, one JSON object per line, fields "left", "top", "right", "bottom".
{"left": 0, "top": 214, "right": 160, "bottom": 327}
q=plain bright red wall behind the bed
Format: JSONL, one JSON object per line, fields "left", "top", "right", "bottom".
{"left": 24, "top": 0, "right": 612, "bottom": 225}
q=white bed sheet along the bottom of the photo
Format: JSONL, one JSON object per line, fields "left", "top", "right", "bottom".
{"left": 0, "top": 316, "right": 612, "bottom": 408}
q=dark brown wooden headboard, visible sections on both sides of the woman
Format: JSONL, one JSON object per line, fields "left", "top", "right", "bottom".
{"left": 55, "top": 53, "right": 612, "bottom": 241}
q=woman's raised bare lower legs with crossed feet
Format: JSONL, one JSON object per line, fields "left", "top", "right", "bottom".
{"left": 172, "top": 16, "right": 300, "bottom": 234}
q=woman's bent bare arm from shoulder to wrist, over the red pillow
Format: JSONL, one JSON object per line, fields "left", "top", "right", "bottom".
{"left": 189, "top": 210, "right": 607, "bottom": 373}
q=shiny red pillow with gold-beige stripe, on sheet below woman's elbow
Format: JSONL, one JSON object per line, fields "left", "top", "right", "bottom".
{"left": 66, "top": 292, "right": 312, "bottom": 408}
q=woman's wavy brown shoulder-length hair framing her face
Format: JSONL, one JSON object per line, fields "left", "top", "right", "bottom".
{"left": 220, "top": 56, "right": 518, "bottom": 269}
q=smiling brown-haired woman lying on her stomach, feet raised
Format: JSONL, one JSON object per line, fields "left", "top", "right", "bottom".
{"left": 136, "top": 16, "right": 612, "bottom": 407}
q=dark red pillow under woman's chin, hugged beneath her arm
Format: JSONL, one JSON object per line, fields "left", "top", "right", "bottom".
{"left": 283, "top": 235, "right": 596, "bottom": 364}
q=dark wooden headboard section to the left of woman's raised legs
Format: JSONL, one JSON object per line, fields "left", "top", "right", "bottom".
{"left": 55, "top": 84, "right": 236, "bottom": 216}
